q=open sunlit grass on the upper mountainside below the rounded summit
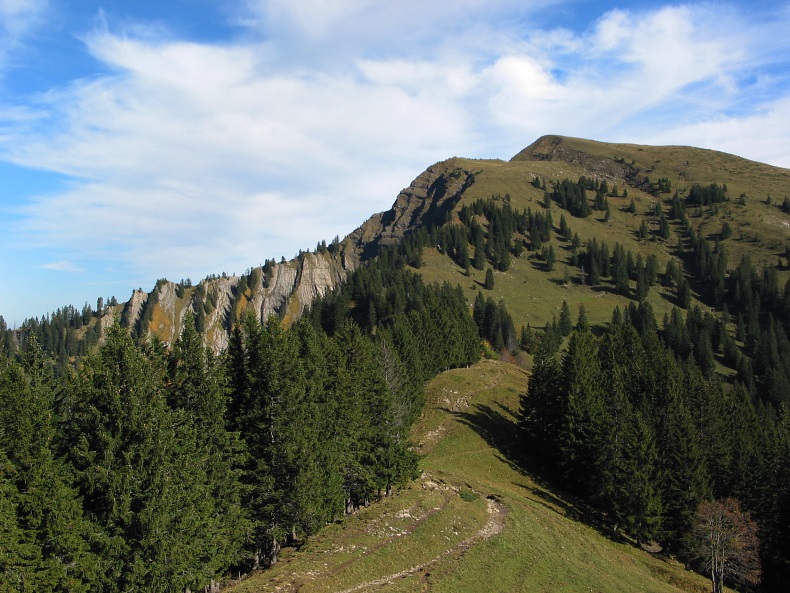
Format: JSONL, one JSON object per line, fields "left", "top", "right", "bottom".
{"left": 408, "top": 136, "right": 790, "bottom": 327}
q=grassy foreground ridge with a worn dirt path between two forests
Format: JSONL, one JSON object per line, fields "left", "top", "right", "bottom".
{"left": 230, "top": 361, "right": 709, "bottom": 593}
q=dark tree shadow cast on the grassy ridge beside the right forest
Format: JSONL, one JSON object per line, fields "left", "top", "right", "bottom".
{"left": 445, "top": 403, "right": 629, "bottom": 543}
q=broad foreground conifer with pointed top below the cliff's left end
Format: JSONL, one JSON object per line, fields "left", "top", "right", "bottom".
{"left": 63, "top": 325, "right": 221, "bottom": 591}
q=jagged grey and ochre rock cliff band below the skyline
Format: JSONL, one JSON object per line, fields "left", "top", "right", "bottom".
{"left": 107, "top": 159, "right": 474, "bottom": 352}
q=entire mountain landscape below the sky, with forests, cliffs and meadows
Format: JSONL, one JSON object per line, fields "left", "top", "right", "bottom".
{"left": 0, "top": 136, "right": 790, "bottom": 593}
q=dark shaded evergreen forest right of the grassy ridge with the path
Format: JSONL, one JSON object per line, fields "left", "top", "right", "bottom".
{"left": 520, "top": 305, "right": 790, "bottom": 590}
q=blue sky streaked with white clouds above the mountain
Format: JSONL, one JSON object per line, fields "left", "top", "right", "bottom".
{"left": 0, "top": 0, "right": 790, "bottom": 326}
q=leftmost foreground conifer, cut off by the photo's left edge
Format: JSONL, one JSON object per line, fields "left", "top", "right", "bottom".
{"left": 0, "top": 338, "right": 100, "bottom": 591}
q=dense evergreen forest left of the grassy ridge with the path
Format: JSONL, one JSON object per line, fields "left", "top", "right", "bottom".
{"left": 0, "top": 256, "right": 480, "bottom": 592}
